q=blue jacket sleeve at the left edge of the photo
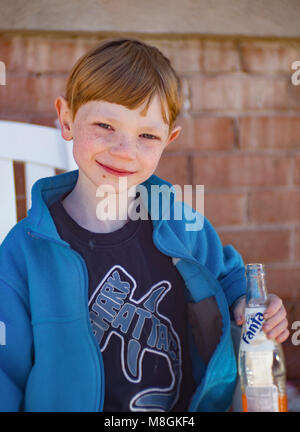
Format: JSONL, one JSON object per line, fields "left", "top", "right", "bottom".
{"left": 0, "top": 231, "right": 33, "bottom": 412}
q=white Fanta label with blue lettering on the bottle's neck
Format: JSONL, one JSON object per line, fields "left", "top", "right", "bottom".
{"left": 240, "top": 307, "right": 273, "bottom": 351}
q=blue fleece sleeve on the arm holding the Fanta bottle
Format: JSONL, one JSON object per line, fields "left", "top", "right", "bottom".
{"left": 193, "top": 214, "right": 246, "bottom": 306}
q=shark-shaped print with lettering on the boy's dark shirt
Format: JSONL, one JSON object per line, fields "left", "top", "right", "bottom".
{"left": 89, "top": 265, "right": 182, "bottom": 411}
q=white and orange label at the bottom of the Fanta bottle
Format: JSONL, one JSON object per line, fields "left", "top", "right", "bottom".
{"left": 243, "top": 385, "right": 279, "bottom": 412}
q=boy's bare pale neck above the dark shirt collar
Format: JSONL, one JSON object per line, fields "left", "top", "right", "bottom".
{"left": 62, "top": 170, "right": 134, "bottom": 233}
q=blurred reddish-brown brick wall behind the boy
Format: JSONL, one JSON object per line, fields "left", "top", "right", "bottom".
{"left": 0, "top": 33, "right": 300, "bottom": 379}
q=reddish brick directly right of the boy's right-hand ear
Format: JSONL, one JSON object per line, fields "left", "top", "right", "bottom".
{"left": 166, "top": 116, "right": 235, "bottom": 151}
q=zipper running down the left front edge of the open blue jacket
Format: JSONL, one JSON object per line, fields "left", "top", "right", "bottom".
{"left": 27, "top": 230, "right": 105, "bottom": 412}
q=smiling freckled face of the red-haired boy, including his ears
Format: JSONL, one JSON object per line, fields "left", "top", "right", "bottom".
{"left": 56, "top": 95, "right": 181, "bottom": 193}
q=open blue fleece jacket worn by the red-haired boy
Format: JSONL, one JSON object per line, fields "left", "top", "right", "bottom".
{"left": 0, "top": 171, "right": 245, "bottom": 412}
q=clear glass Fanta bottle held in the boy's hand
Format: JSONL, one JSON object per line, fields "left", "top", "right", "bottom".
{"left": 238, "top": 264, "right": 287, "bottom": 412}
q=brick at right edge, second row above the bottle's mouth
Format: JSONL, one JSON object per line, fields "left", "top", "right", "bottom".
{"left": 249, "top": 190, "right": 300, "bottom": 224}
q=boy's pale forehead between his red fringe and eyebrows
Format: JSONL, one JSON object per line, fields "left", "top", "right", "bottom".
{"left": 76, "top": 95, "right": 168, "bottom": 129}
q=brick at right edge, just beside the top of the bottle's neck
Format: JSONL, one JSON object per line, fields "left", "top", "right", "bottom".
{"left": 266, "top": 265, "right": 300, "bottom": 300}
